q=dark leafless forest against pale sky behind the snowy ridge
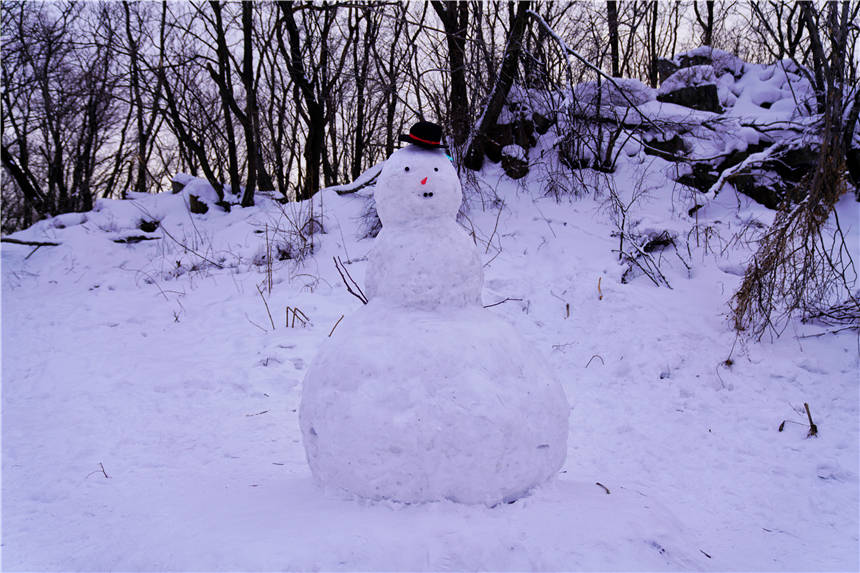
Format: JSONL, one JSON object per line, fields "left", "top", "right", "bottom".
{"left": 0, "top": 0, "right": 860, "bottom": 221}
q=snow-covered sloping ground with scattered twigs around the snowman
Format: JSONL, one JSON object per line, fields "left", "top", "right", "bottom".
{"left": 2, "top": 146, "right": 860, "bottom": 571}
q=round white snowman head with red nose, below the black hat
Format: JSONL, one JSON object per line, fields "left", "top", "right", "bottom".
{"left": 374, "top": 145, "right": 463, "bottom": 225}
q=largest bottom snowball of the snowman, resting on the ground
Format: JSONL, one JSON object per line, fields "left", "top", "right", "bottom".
{"left": 300, "top": 301, "right": 569, "bottom": 505}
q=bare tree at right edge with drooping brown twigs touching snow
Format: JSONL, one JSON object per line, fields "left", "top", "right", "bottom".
{"left": 732, "top": 2, "right": 860, "bottom": 338}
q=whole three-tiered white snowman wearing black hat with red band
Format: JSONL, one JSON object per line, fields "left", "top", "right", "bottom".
{"left": 300, "top": 122, "right": 569, "bottom": 505}
